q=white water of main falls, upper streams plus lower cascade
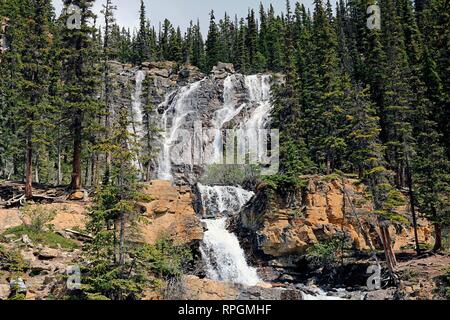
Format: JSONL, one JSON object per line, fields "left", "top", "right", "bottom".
{"left": 158, "top": 75, "right": 271, "bottom": 286}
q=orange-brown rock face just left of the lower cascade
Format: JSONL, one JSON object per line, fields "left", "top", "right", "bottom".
{"left": 141, "top": 180, "right": 203, "bottom": 244}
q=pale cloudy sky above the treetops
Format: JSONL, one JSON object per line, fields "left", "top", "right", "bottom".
{"left": 53, "top": 0, "right": 313, "bottom": 33}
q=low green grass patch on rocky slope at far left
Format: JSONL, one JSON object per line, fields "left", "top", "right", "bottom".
{"left": 3, "top": 225, "right": 79, "bottom": 250}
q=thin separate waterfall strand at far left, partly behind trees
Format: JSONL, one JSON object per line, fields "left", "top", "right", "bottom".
{"left": 128, "top": 70, "right": 145, "bottom": 172}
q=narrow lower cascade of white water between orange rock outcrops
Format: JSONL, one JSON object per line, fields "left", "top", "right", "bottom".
{"left": 199, "top": 185, "right": 261, "bottom": 286}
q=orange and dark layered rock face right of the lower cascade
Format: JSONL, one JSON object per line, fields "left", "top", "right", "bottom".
{"left": 237, "top": 177, "right": 433, "bottom": 258}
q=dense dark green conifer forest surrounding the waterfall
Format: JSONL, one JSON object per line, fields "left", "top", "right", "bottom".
{"left": 0, "top": 0, "right": 450, "bottom": 300}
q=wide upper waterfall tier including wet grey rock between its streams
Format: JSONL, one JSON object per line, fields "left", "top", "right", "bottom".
{"left": 156, "top": 64, "right": 272, "bottom": 184}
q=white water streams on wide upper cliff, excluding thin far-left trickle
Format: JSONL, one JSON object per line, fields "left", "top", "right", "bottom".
{"left": 157, "top": 75, "right": 272, "bottom": 181}
